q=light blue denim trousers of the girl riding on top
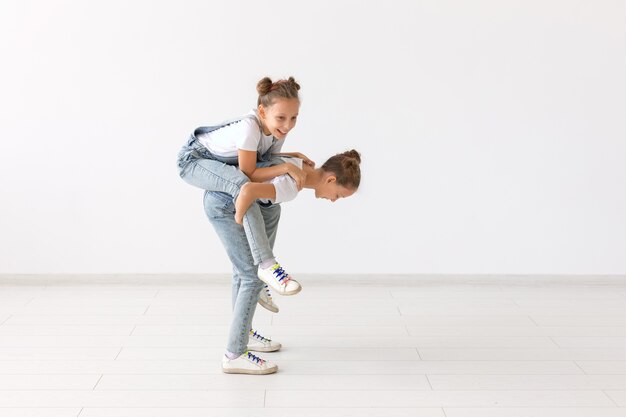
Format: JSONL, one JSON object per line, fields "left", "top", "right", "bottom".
{"left": 178, "top": 136, "right": 272, "bottom": 265}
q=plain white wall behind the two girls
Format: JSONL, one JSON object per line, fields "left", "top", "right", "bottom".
{"left": 0, "top": 0, "right": 626, "bottom": 274}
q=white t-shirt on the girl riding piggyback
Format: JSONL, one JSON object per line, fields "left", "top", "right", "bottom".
{"left": 198, "top": 110, "right": 285, "bottom": 157}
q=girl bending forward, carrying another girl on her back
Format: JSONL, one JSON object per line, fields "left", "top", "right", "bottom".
{"left": 204, "top": 150, "right": 361, "bottom": 375}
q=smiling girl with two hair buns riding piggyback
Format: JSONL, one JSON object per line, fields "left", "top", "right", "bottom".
{"left": 178, "top": 77, "right": 315, "bottom": 295}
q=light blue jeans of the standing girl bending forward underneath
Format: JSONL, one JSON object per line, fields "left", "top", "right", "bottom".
{"left": 204, "top": 191, "right": 280, "bottom": 355}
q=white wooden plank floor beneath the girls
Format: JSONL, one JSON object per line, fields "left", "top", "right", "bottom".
{"left": 0, "top": 275, "right": 626, "bottom": 417}
